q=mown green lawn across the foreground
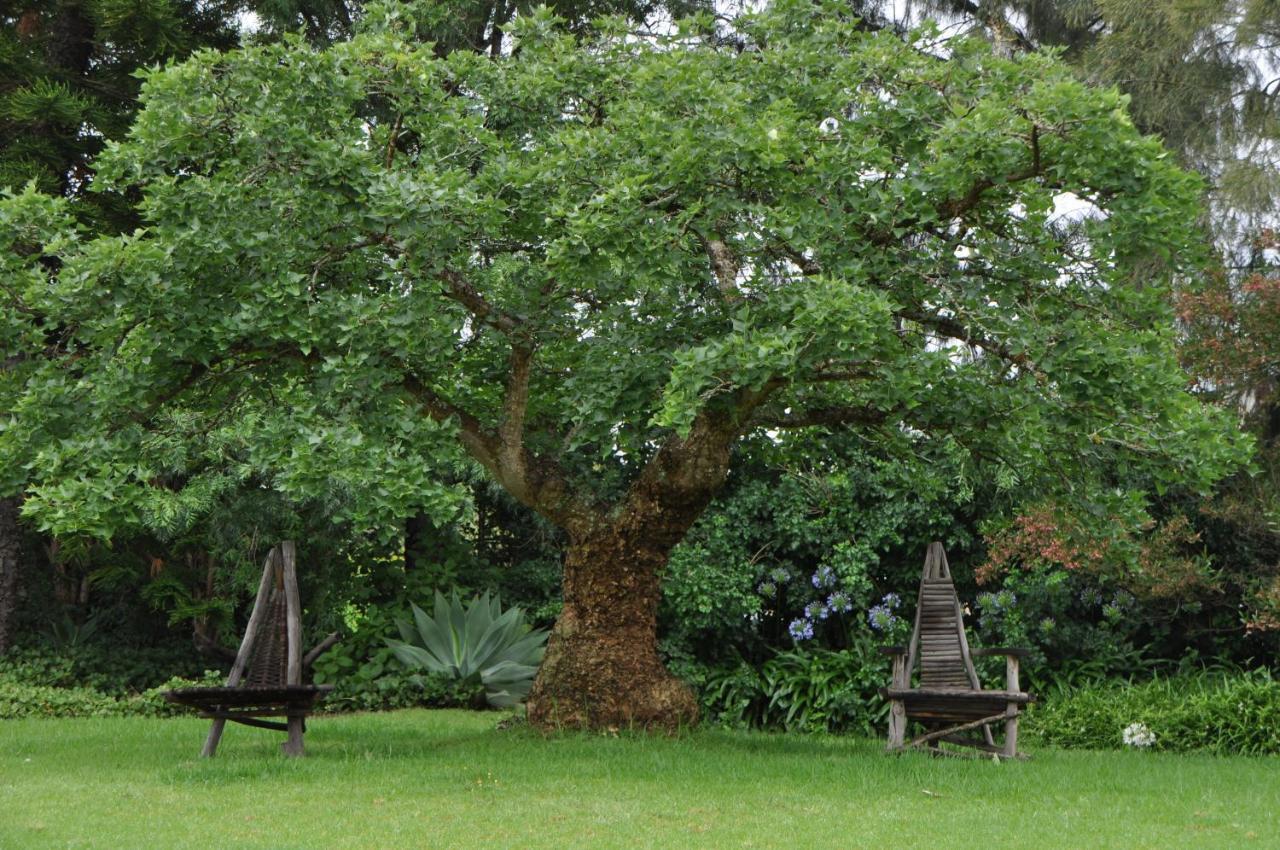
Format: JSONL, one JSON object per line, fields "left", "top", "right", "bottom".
{"left": 0, "top": 712, "right": 1280, "bottom": 850}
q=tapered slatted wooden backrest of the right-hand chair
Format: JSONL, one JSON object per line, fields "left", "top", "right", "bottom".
{"left": 906, "top": 543, "right": 980, "bottom": 690}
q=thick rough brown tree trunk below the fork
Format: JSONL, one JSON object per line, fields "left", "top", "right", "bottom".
{"left": 529, "top": 524, "right": 698, "bottom": 730}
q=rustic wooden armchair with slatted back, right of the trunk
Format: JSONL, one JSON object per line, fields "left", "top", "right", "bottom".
{"left": 881, "top": 543, "right": 1034, "bottom": 758}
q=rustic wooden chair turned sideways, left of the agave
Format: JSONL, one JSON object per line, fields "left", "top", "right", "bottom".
{"left": 164, "top": 540, "right": 338, "bottom": 757}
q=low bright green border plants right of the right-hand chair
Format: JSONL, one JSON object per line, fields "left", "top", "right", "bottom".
{"left": 1028, "top": 668, "right": 1280, "bottom": 754}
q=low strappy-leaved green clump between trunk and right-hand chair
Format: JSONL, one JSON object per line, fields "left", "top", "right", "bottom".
{"left": 700, "top": 639, "right": 888, "bottom": 734}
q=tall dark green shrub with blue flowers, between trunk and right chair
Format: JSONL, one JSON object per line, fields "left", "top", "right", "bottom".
{"left": 662, "top": 434, "right": 974, "bottom": 664}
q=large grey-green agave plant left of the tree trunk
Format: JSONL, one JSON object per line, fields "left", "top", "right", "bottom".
{"left": 387, "top": 590, "right": 548, "bottom": 708}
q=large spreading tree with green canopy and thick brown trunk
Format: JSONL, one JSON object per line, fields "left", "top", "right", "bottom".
{"left": 0, "top": 1, "right": 1239, "bottom": 726}
